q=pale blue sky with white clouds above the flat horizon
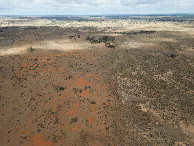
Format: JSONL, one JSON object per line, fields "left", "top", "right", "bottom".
{"left": 0, "top": 0, "right": 194, "bottom": 15}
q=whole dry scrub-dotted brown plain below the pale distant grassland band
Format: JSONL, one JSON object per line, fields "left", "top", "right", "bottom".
{"left": 0, "top": 18, "right": 194, "bottom": 146}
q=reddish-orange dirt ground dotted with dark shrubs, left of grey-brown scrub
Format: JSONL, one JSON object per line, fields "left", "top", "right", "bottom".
{"left": 1, "top": 48, "right": 117, "bottom": 146}
